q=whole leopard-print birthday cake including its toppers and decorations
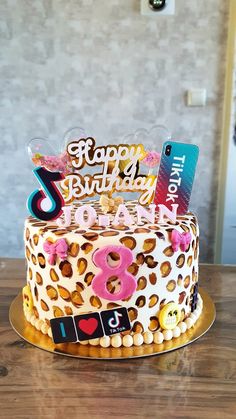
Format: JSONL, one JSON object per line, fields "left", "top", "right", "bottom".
{"left": 23, "top": 138, "right": 202, "bottom": 348}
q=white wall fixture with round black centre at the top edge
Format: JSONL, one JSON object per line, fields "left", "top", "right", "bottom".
{"left": 140, "top": 0, "right": 175, "bottom": 17}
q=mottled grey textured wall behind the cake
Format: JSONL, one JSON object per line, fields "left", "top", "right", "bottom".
{"left": 0, "top": 0, "right": 228, "bottom": 261}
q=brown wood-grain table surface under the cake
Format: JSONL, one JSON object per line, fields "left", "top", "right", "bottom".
{"left": 0, "top": 259, "right": 236, "bottom": 419}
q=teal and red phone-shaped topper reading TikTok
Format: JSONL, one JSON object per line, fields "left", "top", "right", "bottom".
{"left": 154, "top": 141, "right": 199, "bottom": 214}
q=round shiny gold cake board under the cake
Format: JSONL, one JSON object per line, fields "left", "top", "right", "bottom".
{"left": 9, "top": 288, "right": 216, "bottom": 359}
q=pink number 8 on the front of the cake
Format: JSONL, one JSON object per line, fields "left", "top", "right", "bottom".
{"left": 92, "top": 245, "right": 137, "bottom": 301}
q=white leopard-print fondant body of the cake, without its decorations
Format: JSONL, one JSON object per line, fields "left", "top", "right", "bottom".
{"left": 23, "top": 201, "right": 202, "bottom": 347}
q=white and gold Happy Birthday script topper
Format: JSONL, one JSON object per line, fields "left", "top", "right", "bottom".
{"left": 60, "top": 137, "right": 156, "bottom": 205}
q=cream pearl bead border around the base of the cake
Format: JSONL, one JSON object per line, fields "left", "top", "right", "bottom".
{"left": 24, "top": 294, "right": 203, "bottom": 348}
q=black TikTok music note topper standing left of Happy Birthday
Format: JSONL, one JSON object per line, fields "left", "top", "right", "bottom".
{"left": 27, "top": 167, "right": 64, "bottom": 221}
